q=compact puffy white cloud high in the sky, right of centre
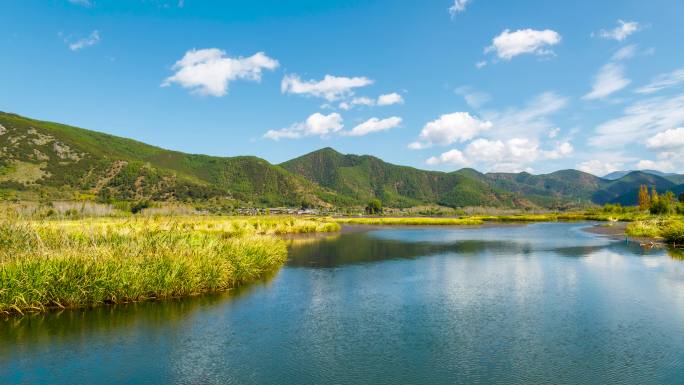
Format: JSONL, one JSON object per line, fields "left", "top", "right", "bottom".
{"left": 485, "top": 28, "right": 561, "bottom": 60}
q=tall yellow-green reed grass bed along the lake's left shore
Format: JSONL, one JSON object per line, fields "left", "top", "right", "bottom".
{"left": 0, "top": 217, "right": 339, "bottom": 314}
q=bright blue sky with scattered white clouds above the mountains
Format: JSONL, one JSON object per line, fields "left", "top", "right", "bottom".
{"left": 0, "top": 0, "right": 684, "bottom": 176}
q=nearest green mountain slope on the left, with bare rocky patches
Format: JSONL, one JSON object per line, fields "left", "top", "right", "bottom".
{"left": 0, "top": 113, "right": 337, "bottom": 206}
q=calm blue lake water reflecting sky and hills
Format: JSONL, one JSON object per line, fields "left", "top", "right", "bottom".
{"left": 0, "top": 223, "right": 684, "bottom": 384}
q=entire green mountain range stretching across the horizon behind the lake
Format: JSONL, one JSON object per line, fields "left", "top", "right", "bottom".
{"left": 0, "top": 113, "right": 684, "bottom": 208}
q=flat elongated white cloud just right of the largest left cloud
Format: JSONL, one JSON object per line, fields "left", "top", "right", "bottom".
{"left": 280, "top": 75, "right": 373, "bottom": 101}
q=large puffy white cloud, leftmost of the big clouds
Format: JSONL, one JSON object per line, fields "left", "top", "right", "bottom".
{"left": 162, "top": 48, "right": 279, "bottom": 97}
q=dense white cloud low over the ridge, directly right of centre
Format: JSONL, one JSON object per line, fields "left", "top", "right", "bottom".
{"left": 409, "top": 112, "right": 492, "bottom": 149}
